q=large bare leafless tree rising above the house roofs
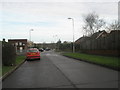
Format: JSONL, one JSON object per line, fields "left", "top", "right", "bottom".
{"left": 83, "top": 13, "right": 106, "bottom": 35}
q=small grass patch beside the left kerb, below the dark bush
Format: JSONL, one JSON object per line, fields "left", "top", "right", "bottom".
{"left": 2, "top": 56, "right": 25, "bottom": 75}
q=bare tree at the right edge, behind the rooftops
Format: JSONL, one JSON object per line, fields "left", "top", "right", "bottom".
{"left": 106, "top": 20, "right": 120, "bottom": 31}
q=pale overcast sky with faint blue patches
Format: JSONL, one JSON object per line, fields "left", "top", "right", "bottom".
{"left": 0, "top": 0, "right": 118, "bottom": 43}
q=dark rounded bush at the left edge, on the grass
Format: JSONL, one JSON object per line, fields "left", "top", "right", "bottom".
{"left": 2, "top": 42, "right": 16, "bottom": 66}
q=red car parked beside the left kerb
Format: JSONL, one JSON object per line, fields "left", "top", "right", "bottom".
{"left": 26, "top": 48, "right": 40, "bottom": 60}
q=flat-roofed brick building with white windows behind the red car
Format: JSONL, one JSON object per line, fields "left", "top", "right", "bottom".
{"left": 8, "top": 39, "right": 28, "bottom": 53}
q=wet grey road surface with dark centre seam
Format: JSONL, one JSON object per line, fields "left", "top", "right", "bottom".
{"left": 2, "top": 51, "right": 118, "bottom": 88}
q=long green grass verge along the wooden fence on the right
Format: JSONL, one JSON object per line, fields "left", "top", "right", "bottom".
{"left": 63, "top": 53, "right": 120, "bottom": 68}
